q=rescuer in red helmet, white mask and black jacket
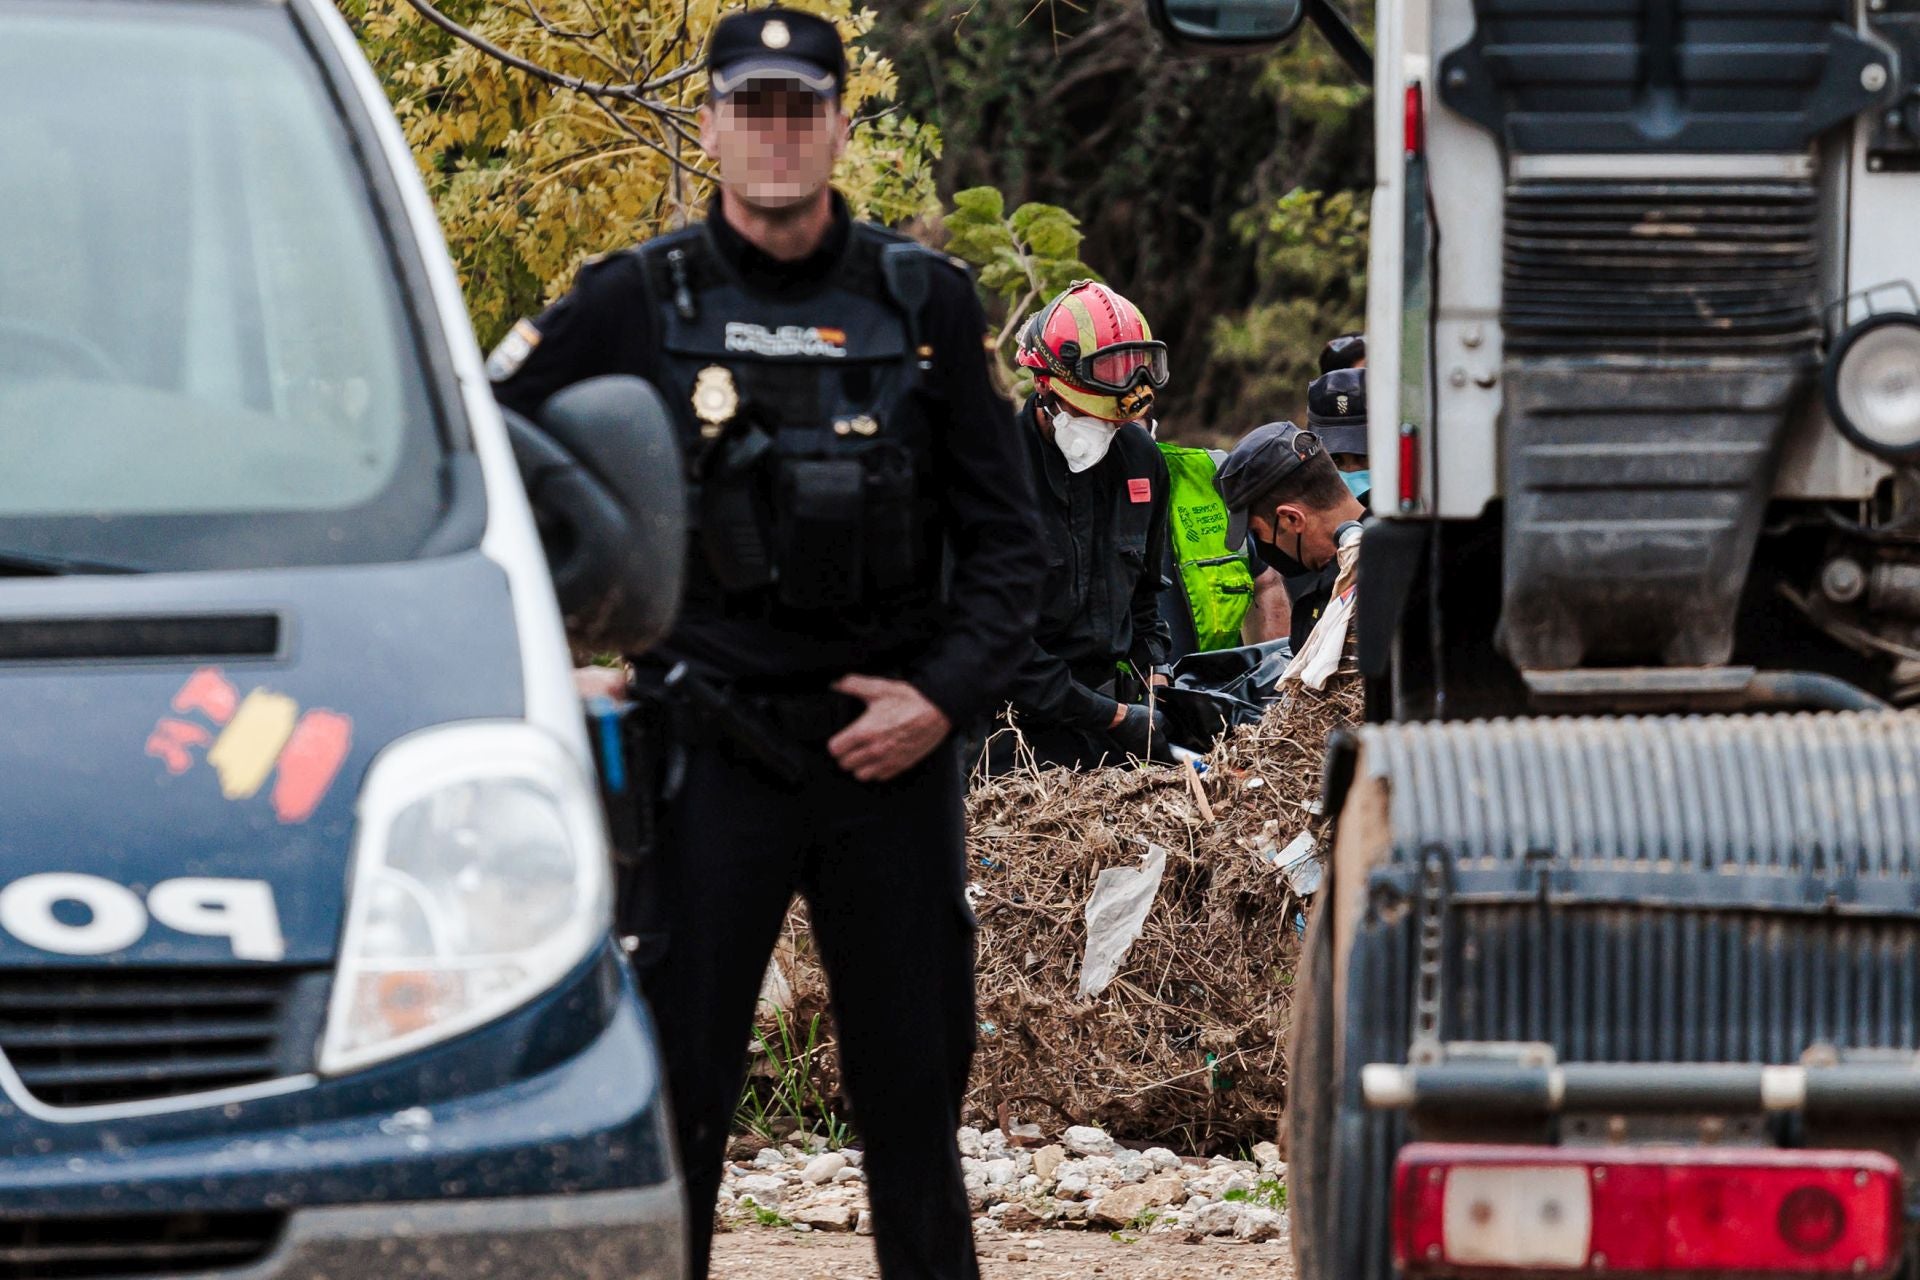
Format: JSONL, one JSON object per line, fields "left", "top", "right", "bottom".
{"left": 987, "top": 280, "right": 1173, "bottom": 771}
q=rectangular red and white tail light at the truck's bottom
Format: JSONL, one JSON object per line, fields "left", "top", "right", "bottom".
{"left": 1394, "top": 1142, "right": 1901, "bottom": 1276}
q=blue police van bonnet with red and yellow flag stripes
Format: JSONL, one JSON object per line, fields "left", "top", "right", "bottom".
{"left": 0, "top": 553, "right": 524, "bottom": 967}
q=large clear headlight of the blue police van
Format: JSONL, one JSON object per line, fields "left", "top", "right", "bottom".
{"left": 321, "top": 723, "right": 612, "bottom": 1075}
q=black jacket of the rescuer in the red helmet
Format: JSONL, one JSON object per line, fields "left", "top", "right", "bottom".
{"left": 1012, "top": 399, "right": 1173, "bottom": 733}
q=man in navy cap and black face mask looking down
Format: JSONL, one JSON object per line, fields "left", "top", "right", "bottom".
{"left": 1219, "top": 422, "right": 1367, "bottom": 652}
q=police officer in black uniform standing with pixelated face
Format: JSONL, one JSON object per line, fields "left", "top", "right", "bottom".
{"left": 492, "top": 8, "right": 1044, "bottom": 1278}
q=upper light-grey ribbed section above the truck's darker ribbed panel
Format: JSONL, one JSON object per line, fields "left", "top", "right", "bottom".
{"left": 1363, "top": 712, "right": 1920, "bottom": 882}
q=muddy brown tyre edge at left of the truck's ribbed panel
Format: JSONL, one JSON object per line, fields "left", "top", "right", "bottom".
{"left": 1286, "top": 890, "right": 1338, "bottom": 1280}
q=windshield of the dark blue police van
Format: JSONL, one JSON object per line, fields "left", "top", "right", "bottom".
{"left": 0, "top": 0, "right": 445, "bottom": 572}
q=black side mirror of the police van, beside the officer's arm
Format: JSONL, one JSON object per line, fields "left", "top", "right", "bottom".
{"left": 505, "top": 374, "right": 687, "bottom": 652}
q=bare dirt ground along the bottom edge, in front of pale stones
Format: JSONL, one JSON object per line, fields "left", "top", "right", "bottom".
{"left": 712, "top": 1228, "right": 1294, "bottom": 1280}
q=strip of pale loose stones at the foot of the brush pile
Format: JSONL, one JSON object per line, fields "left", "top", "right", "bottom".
{"left": 718, "top": 1126, "right": 1288, "bottom": 1242}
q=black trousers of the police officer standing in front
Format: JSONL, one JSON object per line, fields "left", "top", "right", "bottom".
{"left": 637, "top": 741, "right": 979, "bottom": 1280}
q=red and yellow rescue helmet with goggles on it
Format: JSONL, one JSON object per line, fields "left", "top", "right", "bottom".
{"left": 1016, "top": 280, "right": 1167, "bottom": 422}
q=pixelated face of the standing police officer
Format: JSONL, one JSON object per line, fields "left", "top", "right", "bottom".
{"left": 701, "top": 81, "right": 847, "bottom": 213}
